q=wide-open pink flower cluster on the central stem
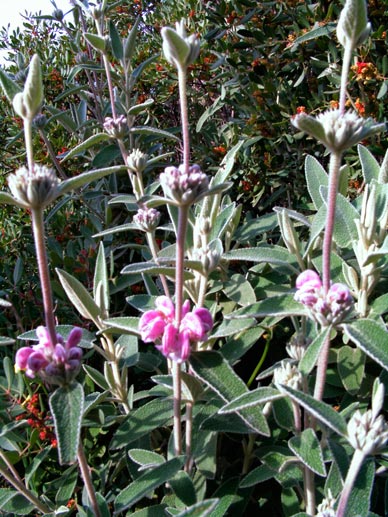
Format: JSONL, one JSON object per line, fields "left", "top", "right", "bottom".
{"left": 139, "top": 296, "right": 213, "bottom": 363}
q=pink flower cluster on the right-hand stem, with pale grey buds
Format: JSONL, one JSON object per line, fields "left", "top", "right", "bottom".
{"left": 295, "top": 269, "right": 353, "bottom": 326}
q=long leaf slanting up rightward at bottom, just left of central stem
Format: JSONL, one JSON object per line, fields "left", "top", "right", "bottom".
{"left": 114, "top": 456, "right": 185, "bottom": 512}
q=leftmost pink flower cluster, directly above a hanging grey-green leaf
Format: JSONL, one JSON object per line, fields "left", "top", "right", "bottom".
{"left": 15, "top": 326, "right": 82, "bottom": 385}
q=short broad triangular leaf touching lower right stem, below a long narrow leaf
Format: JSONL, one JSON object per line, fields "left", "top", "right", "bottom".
{"left": 288, "top": 429, "right": 326, "bottom": 476}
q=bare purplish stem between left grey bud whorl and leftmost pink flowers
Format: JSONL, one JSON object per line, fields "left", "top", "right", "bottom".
{"left": 31, "top": 208, "right": 57, "bottom": 347}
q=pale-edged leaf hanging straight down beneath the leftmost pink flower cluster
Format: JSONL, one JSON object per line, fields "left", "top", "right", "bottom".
{"left": 49, "top": 382, "right": 84, "bottom": 465}
